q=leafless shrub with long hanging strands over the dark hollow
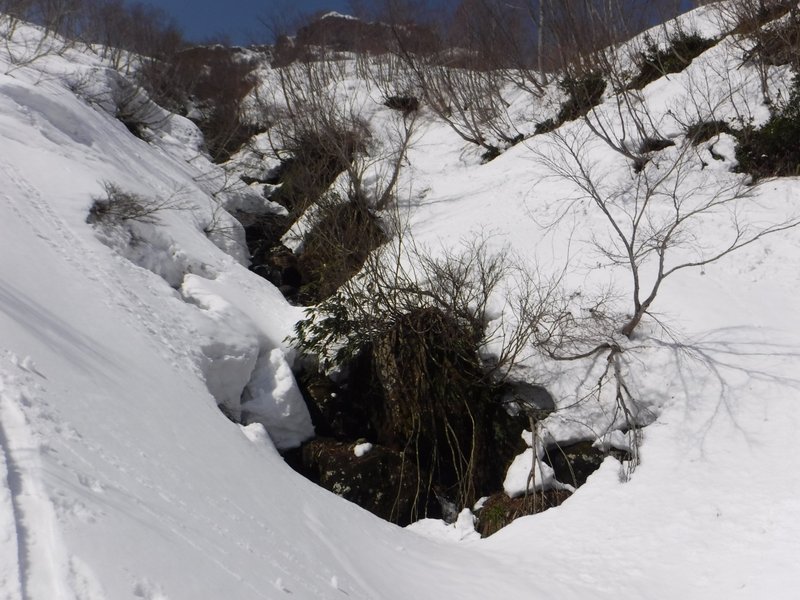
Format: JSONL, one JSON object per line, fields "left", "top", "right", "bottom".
{"left": 294, "top": 236, "right": 552, "bottom": 516}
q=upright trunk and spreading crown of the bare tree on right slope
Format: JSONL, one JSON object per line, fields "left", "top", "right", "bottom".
{"left": 540, "top": 124, "right": 800, "bottom": 338}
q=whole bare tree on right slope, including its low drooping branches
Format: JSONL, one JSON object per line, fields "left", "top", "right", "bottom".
{"left": 536, "top": 95, "right": 800, "bottom": 474}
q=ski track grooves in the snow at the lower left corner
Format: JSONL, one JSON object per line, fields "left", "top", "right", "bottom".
{"left": 0, "top": 352, "right": 107, "bottom": 600}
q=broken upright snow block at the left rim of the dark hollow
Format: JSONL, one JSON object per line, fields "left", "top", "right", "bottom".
{"left": 242, "top": 348, "right": 314, "bottom": 450}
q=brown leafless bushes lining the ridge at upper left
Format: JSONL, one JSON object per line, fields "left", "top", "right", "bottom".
{"left": 0, "top": 0, "right": 261, "bottom": 162}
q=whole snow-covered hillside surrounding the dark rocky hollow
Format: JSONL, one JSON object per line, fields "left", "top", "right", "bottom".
{"left": 0, "top": 8, "right": 800, "bottom": 600}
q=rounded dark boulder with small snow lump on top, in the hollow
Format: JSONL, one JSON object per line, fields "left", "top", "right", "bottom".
{"left": 300, "top": 438, "right": 437, "bottom": 526}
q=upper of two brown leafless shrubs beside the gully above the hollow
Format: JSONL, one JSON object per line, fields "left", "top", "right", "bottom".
{"left": 262, "top": 49, "right": 416, "bottom": 216}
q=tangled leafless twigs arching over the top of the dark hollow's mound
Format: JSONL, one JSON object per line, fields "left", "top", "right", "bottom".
{"left": 296, "top": 234, "right": 542, "bottom": 381}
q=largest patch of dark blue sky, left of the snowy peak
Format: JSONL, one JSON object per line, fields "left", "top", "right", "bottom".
{"left": 147, "top": 0, "right": 350, "bottom": 44}
